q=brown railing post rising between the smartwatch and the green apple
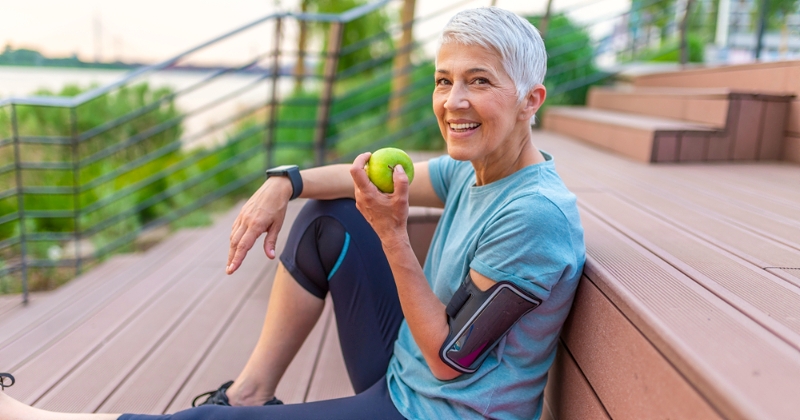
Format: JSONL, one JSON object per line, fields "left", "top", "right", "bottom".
{"left": 314, "top": 22, "right": 344, "bottom": 166}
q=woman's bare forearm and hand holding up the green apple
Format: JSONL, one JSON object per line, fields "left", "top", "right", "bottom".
{"left": 350, "top": 153, "right": 460, "bottom": 380}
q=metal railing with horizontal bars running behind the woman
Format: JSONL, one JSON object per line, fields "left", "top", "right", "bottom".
{"left": 0, "top": 0, "right": 712, "bottom": 301}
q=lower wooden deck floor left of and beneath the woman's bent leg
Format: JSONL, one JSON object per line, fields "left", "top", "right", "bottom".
{"left": 0, "top": 201, "right": 353, "bottom": 413}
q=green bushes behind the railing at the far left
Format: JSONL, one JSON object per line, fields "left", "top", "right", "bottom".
{"left": 0, "top": 84, "right": 266, "bottom": 290}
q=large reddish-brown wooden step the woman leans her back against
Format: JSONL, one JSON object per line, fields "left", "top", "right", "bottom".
{"left": 535, "top": 132, "right": 800, "bottom": 418}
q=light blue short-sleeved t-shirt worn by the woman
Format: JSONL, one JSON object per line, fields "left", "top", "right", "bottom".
{"left": 386, "top": 153, "right": 585, "bottom": 419}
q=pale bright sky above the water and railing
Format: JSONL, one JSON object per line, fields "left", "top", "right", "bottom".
{"left": 0, "top": 0, "right": 628, "bottom": 62}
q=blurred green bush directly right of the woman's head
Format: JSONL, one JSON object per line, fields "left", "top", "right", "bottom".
{"left": 528, "top": 14, "right": 605, "bottom": 110}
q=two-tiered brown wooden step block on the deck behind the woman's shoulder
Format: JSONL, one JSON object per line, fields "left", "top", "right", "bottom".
{"left": 544, "top": 86, "right": 794, "bottom": 162}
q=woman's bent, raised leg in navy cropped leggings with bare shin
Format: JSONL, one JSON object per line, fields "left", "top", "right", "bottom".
{"left": 226, "top": 199, "right": 403, "bottom": 406}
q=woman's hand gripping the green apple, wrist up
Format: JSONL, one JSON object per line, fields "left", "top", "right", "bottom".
{"left": 350, "top": 152, "right": 408, "bottom": 247}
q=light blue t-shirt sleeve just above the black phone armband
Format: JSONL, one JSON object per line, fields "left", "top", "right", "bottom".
{"left": 470, "top": 196, "right": 578, "bottom": 301}
